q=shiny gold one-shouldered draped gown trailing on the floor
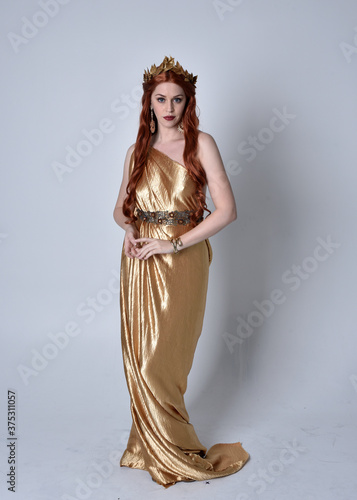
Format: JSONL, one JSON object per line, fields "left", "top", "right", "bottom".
{"left": 120, "top": 147, "right": 249, "bottom": 488}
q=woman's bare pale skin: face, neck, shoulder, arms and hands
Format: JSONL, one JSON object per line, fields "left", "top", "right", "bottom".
{"left": 113, "top": 82, "right": 237, "bottom": 260}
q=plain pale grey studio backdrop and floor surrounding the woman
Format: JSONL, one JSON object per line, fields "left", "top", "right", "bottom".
{"left": 0, "top": 0, "right": 357, "bottom": 500}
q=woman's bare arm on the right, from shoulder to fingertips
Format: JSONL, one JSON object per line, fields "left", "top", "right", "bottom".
{"left": 136, "top": 132, "right": 237, "bottom": 259}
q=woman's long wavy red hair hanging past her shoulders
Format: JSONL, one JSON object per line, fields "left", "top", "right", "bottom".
{"left": 123, "top": 70, "right": 211, "bottom": 225}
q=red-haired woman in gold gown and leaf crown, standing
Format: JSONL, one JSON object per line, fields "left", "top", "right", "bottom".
{"left": 113, "top": 57, "right": 249, "bottom": 488}
